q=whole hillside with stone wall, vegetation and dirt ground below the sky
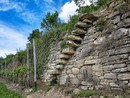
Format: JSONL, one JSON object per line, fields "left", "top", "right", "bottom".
{"left": 0, "top": 0, "right": 130, "bottom": 98}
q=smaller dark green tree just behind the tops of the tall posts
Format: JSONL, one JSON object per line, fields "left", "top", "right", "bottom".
{"left": 28, "top": 29, "right": 42, "bottom": 43}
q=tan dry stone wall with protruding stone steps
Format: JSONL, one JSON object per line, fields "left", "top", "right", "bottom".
{"left": 45, "top": 1, "right": 130, "bottom": 90}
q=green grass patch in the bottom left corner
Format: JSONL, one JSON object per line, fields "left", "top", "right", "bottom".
{"left": 0, "top": 83, "right": 24, "bottom": 98}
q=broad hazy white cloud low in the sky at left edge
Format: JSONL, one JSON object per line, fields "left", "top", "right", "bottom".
{"left": 0, "top": 23, "right": 27, "bottom": 57}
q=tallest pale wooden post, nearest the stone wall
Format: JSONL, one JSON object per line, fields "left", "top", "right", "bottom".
{"left": 33, "top": 39, "right": 37, "bottom": 89}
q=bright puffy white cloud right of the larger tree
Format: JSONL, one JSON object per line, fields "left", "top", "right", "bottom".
{"left": 59, "top": 1, "right": 78, "bottom": 22}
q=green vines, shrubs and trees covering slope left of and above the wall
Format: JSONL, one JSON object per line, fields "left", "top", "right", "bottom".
{"left": 0, "top": 0, "right": 109, "bottom": 89}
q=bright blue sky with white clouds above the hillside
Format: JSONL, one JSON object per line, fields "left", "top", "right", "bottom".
{"left": 0, "top": 0, "right": 88, "bottom": 57}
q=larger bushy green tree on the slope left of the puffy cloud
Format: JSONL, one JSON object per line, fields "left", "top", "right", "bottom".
{"left": 41, "top": 11, "right": 61, "bottom": 30}
